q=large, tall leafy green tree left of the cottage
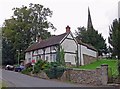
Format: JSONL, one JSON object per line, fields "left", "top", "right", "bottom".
{"left": 2, "top": 3, "right": 56, "bottom": 64}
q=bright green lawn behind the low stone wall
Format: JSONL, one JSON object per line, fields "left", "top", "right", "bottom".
{"left": 76, "top": 59, "right": 118, "bottom": 76}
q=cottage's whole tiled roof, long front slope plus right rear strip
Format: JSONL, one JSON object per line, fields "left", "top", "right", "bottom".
{"left": 25, "top": 33, "right": 97, "bottom": 52}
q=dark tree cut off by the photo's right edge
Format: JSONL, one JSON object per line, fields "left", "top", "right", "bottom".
{"left": 108, "top": 19, "right": 120, "bottom": 77}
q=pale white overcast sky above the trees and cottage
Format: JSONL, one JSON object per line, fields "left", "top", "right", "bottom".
{"left": 0, "top": 0, "right": 120, "bottom": 43}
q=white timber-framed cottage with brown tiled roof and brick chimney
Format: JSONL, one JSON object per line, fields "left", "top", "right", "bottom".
{"left": 25, "top": 26, "right": 97, "bottom": 65}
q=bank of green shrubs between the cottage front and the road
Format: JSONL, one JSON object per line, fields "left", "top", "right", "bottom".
{"left": 22, "top": 60, "right": 65, "bottom": 79}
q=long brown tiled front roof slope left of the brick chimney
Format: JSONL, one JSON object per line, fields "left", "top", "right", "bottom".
{"left": 25, "top": 33, "right": 68, "bottom": 52}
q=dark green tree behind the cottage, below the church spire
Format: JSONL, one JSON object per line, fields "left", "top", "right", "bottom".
{"left": 75, "top": 27, "right": 107, "bottom": 55}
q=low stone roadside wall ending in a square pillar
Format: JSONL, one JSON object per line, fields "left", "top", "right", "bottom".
{"left": 61, "top": 65, "right": 108, "bottom": 85}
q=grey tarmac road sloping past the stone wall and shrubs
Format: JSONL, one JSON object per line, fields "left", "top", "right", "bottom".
{"left": 0, "top": 69, "right": 119, "bottom": 89}
